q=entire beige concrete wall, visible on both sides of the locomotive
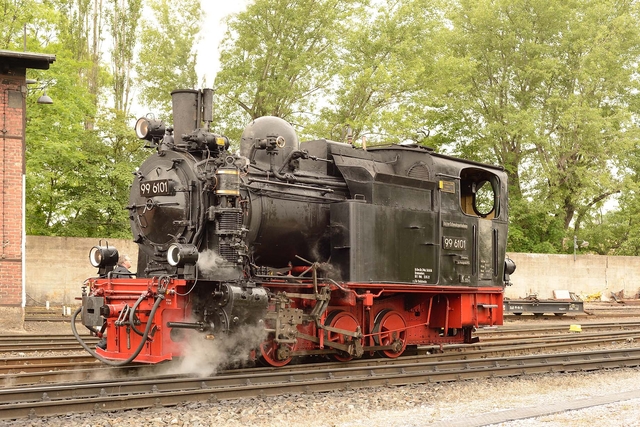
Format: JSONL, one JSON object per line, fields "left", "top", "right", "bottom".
{"left": 18, "top": 236, "right": 640, "bottom": 306}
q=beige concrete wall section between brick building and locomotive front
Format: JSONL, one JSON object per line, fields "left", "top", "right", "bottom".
{"left": 26, "top": 236, "right": 138, "bottom": 306}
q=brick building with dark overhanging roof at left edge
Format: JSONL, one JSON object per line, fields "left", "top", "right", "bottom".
{"left": 0, "top": 50, "right": 56, "bottom": 308}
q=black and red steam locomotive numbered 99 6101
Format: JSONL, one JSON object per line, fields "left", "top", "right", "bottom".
{"left": 72, "top": 89, "right": 515, "bottom": 366}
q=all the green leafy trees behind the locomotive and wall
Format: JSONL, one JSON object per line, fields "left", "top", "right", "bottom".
{"left": 6, "top": 0, "right": 640, "bottom": 255}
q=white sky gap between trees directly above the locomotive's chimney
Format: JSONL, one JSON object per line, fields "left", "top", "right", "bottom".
{"left": 196, "top": 0, "right": 249, "bottom": 88}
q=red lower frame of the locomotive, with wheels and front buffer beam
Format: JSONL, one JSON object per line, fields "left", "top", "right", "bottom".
{"left": 82, "top": 277, "right": 503, "bottom": 366}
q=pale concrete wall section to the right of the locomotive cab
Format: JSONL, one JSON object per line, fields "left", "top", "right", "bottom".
{"left": 505, "top": 253, "right": 640, "bottom": 301}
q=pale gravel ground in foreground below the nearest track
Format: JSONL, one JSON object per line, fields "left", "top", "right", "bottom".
{"left": 8, "top": 368, "right": 640, "bottom": 427}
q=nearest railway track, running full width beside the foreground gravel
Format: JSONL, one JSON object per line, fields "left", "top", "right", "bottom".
{"left": 0, "top": 347, "right": 640, "bottom": 420}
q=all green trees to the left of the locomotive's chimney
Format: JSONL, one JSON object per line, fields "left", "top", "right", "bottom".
{"left": 9, "top": 0, "right": 199, "bottom": 237}
